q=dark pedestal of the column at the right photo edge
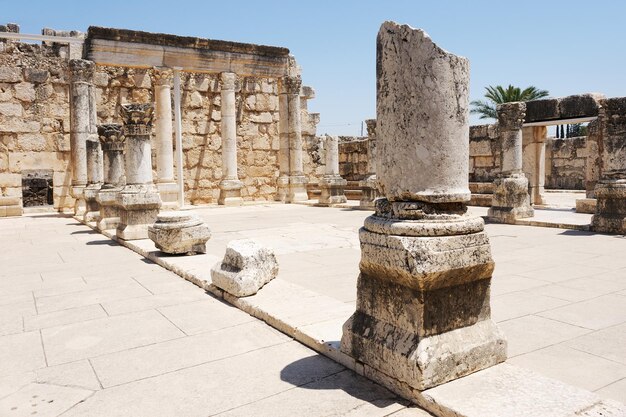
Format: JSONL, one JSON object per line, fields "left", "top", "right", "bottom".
{"left": 591, "top": 179, "right": 626, "bottom": 235}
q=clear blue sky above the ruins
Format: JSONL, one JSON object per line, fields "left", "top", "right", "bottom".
{"left": 0, "top": 0, "right": 626, "bottom": 135}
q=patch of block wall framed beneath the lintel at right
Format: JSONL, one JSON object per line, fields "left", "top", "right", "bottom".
{"left": 545, "top": 136, "right": 587, "bottom": 190}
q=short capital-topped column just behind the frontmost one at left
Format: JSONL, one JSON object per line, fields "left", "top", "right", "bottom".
{"left": 97, "top": 124, "right": 126, "bottom": 230}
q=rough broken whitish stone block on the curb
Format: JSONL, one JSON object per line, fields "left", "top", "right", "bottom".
{"left": 211, "top": 239, "right": 278, "bottom": 297}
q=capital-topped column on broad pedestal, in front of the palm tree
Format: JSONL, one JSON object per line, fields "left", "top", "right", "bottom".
{"left": 488, "top": 102, "right": 534, "bottom": 223}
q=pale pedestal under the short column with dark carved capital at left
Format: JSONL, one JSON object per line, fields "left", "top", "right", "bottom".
{"left": 115, "top": 185, "right": 161, "bottom": 240}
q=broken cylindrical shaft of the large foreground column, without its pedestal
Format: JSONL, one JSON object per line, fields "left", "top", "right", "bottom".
{"left": 376, "top": 22, "right": 470, "bottom": 203}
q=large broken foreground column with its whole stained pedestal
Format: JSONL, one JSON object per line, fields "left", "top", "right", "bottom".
{"left": 341, "top": 22, "right": 506, "bottom": 392}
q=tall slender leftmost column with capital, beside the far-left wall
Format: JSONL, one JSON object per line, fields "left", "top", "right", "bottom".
{"left": 69, "top": 59, "right": 96, "bottom": 216}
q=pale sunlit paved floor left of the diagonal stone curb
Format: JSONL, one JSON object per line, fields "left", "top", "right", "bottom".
{"left": 0, "top": 214, "right": 428, "bottom": 417}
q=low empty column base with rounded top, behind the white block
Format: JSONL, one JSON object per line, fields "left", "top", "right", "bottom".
{"left": 148, "top": 211, "right": 211, "bottom": 255}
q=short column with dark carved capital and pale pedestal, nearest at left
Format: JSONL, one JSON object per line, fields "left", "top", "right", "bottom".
{"left": 116, "top": 104, "right": 161, "bottom": 240}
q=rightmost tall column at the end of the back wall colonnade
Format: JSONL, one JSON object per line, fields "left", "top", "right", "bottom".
{"left": 279, "top": 76, "right": 308, "bottom": 203}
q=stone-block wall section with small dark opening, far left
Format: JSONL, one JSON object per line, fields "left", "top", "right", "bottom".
{"left": 0, "top": 41, "right": 74, "bottom": 210}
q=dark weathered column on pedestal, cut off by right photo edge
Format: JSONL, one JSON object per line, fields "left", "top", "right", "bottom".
{"left": 591, "top": 97, "right": 626, "bottom": 234}
